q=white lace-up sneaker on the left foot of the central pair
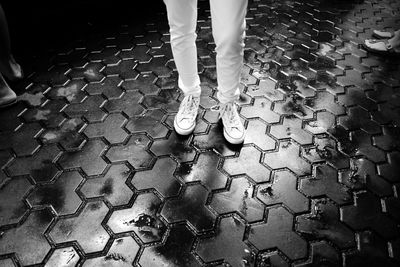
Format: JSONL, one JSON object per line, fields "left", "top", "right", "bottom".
{"left": 174, "top": 95, "right": 200, "bottom": 135}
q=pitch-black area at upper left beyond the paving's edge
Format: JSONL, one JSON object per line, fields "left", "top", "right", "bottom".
{"left": 1, "top": 0, "right": 165, "bottom": 68}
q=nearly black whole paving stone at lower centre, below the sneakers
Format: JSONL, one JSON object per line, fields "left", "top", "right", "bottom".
{"left": 161, "top": 184, "right": 216, "bottom": 232}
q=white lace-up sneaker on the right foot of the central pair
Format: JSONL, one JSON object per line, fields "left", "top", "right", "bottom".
{"left": 219, "top": 102, "right": 246, "bottom": 145}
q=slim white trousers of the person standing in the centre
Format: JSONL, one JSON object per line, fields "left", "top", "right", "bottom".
{"left": 164, "top": 0, "right": 248, "bottom": 104}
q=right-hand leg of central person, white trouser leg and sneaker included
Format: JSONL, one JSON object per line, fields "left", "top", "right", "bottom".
{"left": 210, "top": 0, "right": 248, "bottom": 144}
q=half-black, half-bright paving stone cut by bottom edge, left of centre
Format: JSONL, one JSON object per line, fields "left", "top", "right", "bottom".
{"left": 139, "top": 225, "right": 200, "bottom": 267}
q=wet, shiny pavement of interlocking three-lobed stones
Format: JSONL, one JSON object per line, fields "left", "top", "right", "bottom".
{"left": 0, "top": 0, "right": 400, "bottom": 267}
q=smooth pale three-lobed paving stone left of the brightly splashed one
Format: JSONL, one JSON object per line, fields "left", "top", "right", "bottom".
{"left": 49, "top": 201, "right": 110, "bottom": 253}
